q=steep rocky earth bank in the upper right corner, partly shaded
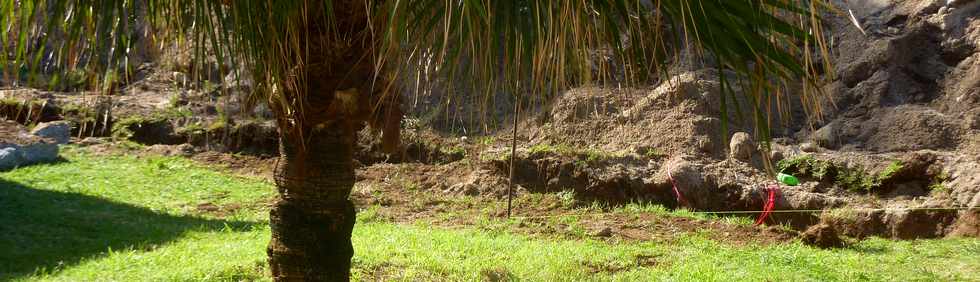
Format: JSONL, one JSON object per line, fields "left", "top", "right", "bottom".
{"left": 812, "top": 1, "right": 980, "bottom": 154}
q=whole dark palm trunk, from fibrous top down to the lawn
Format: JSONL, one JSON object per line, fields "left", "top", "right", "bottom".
{"left": 267, "top": 1, "right": 401, "bottom": 281}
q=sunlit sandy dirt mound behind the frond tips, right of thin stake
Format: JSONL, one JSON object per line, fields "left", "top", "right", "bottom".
{"left": 523, "top": 72, "right": 752, "bottom": 160}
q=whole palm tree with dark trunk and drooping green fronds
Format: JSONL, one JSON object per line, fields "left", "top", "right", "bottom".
{"left": 0, "top": 0, "right": 829, "bottom": 281}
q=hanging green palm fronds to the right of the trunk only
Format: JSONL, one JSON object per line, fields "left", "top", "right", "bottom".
{"left": 375, "top": 0, "right": 830, "bottom": 138}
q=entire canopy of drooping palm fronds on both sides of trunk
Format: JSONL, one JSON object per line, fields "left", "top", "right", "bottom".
{"left": 0, "top": 0, "right": 830, "bottom": 148}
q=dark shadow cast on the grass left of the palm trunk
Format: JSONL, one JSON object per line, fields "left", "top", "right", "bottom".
{"left": 0, "top": 179, "right": 259, "bottom": 281}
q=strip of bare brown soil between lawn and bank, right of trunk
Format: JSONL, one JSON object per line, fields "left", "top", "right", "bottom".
{"left": 352, "top": 162, "right": 796, "bottom": 245}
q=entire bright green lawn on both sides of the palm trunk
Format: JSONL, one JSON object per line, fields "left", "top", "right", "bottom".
{"left": 0, "top": 148, "right": 980, "bottom": 281}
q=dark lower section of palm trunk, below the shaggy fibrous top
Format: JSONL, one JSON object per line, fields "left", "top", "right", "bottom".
{"left": 268, "top": 122, "right": 355, "bottom": 281}
